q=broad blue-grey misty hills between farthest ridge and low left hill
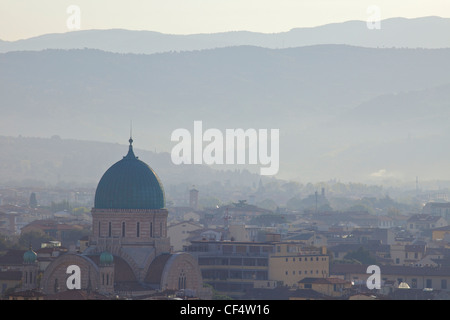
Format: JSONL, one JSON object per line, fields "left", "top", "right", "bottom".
{"left": 0, "top": 45, "right": 450, "bottom": 181}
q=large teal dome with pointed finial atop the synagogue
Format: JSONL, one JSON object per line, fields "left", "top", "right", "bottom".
{"left": 94, "top": 138, "right": 165, "bottom": 209}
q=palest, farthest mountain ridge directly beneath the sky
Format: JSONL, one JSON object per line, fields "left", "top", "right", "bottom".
{"left": 0, "top": 17, "right": 450, "bottom": 54}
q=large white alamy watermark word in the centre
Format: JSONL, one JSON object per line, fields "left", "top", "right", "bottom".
{"left": 171, "top": 121, "right": 280, "bottom": 175}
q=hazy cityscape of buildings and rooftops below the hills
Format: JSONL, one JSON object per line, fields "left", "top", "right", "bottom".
{"left": 0, "top": 148, "right": 450, "bottom": 300}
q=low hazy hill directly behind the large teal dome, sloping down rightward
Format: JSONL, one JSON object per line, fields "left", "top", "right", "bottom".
{"left": 0, "top": 136, "right": 260, "bottom": 190}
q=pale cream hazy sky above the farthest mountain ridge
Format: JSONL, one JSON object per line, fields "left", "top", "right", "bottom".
{"left": 0, "top": 0, "right": 450, "bottom": 41}
